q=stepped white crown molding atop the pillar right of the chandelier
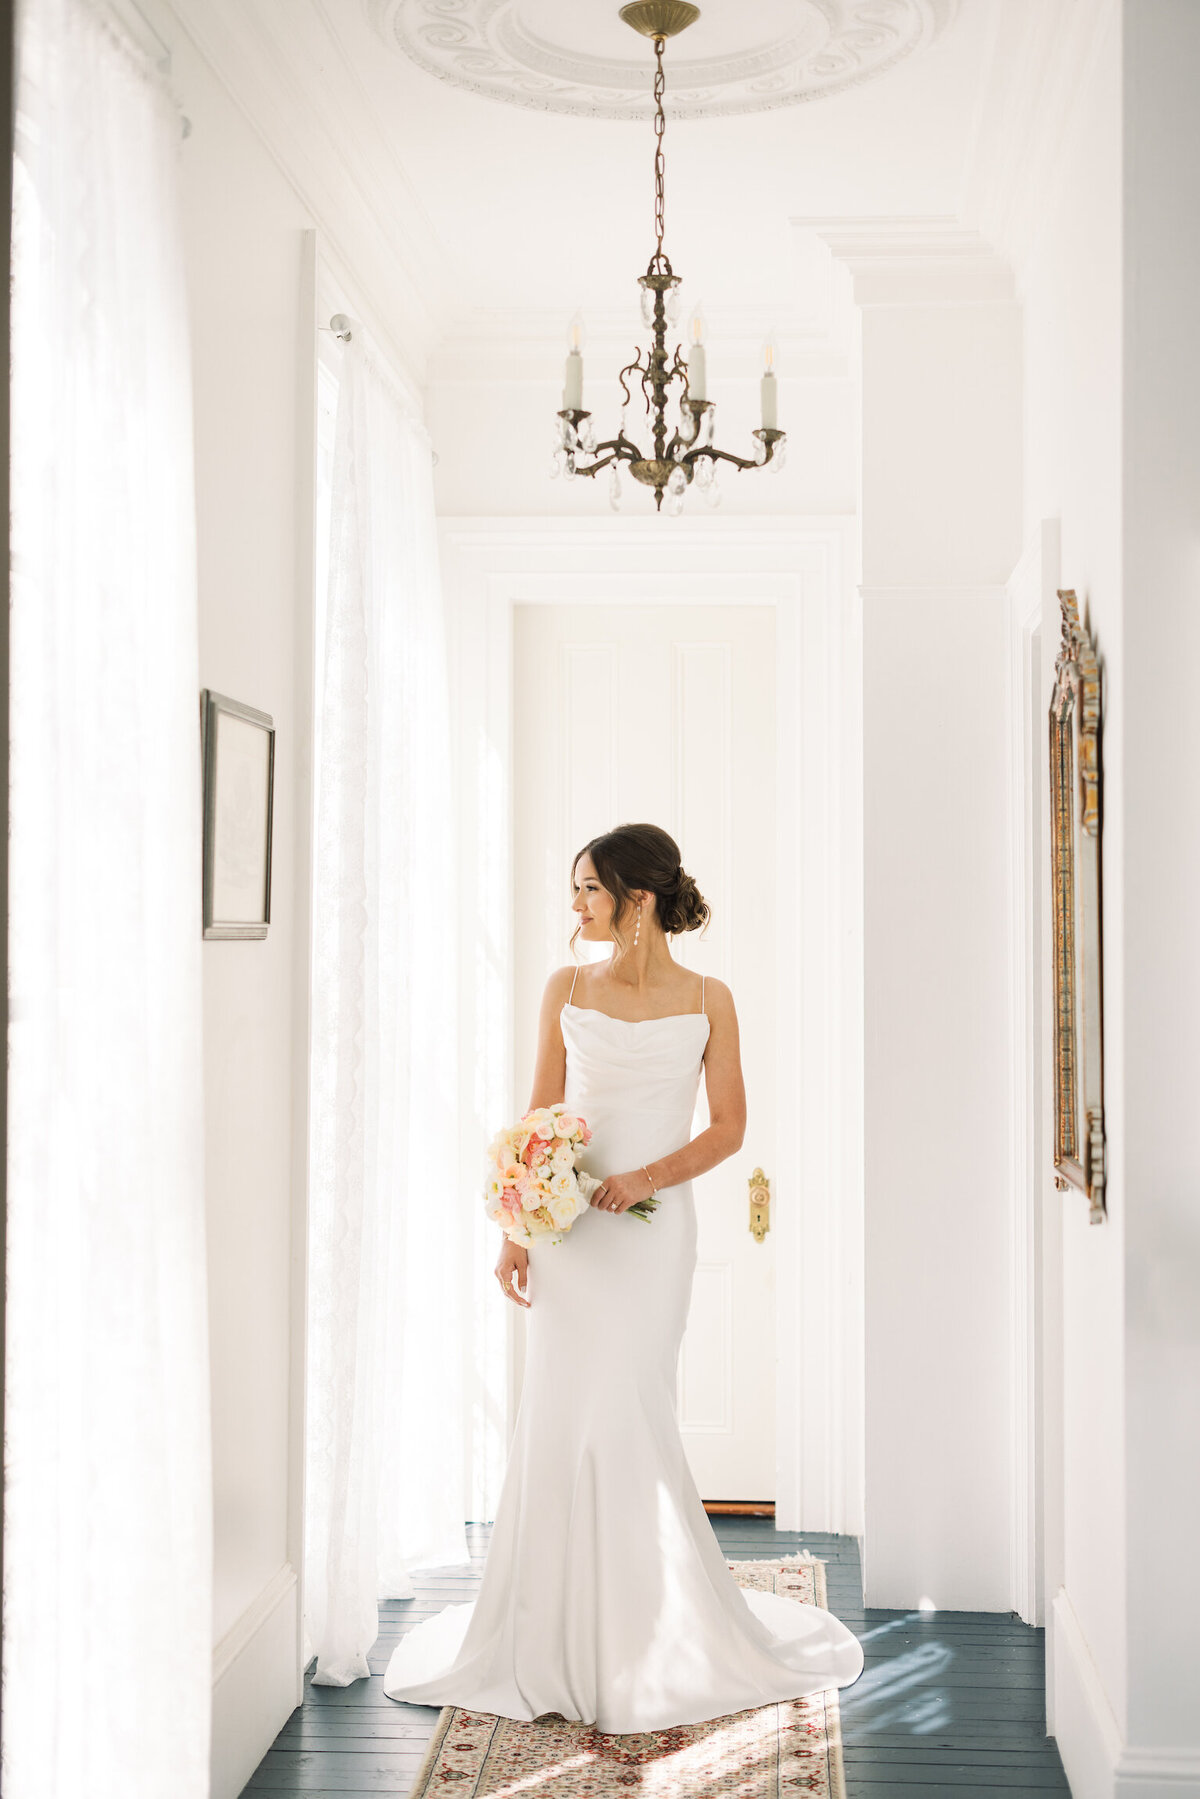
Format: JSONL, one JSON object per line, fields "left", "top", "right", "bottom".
{"left": 792, "top": 214, "right": 1015, "bottom": 306}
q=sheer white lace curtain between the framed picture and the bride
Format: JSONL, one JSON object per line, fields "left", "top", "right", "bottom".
{"left": 306, "top": 329, "right": 470, "bottom": 1686}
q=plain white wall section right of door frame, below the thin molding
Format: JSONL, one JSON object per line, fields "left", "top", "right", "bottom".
{"left": 864, "top": 588, "right": 1013, "bottom": 1612}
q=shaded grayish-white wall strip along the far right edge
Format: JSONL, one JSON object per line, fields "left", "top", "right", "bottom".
{"left": 1115, "top": 0, "right": 1200, "bottom": 1795}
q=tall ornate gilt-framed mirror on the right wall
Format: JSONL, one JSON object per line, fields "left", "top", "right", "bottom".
{"left": 1051, "top": 588, "right": 1105, "bottom": 1223}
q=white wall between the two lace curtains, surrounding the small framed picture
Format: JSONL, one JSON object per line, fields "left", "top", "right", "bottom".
{"left": 141, "top": 7, "right": 313, "bottom": 1799}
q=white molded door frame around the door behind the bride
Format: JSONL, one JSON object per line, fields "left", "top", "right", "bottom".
{"left": 441, "top": 515, "right": 864, "bottom": 1535}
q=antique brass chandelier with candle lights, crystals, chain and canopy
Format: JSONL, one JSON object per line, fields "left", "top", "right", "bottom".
{"left": 552, "top": 0, "right": 784, "bottom": 515}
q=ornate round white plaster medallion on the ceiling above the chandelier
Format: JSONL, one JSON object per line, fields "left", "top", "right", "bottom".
{"left": 363, "top": 0, "right": 957, "bottom": 119}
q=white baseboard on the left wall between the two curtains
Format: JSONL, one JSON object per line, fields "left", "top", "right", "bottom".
{"left": 209, "top": 1562, "right": 302, "bottom": 1799}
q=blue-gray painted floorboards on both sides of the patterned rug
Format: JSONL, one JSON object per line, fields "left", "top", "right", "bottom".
{"left": 245, "top": 1518, "right": 1070, "bottom": 1799}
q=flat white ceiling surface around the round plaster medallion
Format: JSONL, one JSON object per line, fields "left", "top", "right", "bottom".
{"left": 332, "top": 0, "right": 990, "bottom": 315}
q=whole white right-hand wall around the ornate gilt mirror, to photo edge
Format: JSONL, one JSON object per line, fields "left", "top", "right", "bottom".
{"left": 1024, "top": 0, "right": 1200, "bottom": 1799}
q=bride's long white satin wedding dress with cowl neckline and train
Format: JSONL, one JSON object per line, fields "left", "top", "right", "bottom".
{"left": 383, "top": 982, "right": 864, "bottom": 1732}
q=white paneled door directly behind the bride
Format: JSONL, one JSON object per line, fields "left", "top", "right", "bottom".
{"left": 513, "top": 604, "right": 777, "bottom": 1500}
